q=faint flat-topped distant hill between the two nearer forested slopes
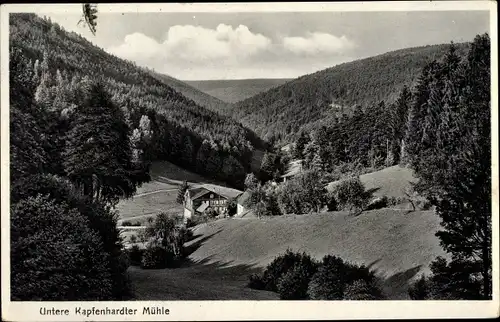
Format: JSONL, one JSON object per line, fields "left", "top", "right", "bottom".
{"left": 184, "top": 78, "right": 291, "bottom": 103}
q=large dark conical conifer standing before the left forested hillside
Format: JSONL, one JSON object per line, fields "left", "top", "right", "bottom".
{"left": 64, "top": 83, "right": 149, "bottom": 203}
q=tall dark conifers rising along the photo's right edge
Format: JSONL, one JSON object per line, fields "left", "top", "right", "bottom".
{"left": 408, "top": 34, "right": 492, "bottom": 299}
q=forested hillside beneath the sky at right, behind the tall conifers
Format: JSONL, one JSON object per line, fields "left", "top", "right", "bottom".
{"left": 232, "top": 44, "right": 467, "bottom": 142}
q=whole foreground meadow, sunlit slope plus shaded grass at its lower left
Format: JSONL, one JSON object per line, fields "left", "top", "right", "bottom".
{"left": 131, "top": 209, "right": 445, "bottom": 300}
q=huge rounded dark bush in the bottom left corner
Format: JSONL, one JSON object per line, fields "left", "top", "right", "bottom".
{"left": 10, "top": 195, "right": 114, "bottom": 301}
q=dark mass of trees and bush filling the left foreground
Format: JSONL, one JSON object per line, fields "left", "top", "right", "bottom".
{"left": 9, "top": 46, "right": 141, "bottom": 300}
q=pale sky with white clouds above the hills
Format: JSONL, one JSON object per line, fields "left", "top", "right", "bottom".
{"left": 46, "top": 11, "right": 489, "bottom": 80}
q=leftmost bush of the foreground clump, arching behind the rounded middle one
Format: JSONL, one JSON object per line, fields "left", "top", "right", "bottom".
{"left": 248, "top": 249, "right": 318, "bottom": 292}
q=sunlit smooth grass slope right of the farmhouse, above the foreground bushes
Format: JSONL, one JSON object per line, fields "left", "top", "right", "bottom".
{"left": 187, "top": 209, "right": 445, "bottom": 299}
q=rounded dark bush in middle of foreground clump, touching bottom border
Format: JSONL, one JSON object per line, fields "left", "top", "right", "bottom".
{"left": 277, "top": 263, "right": 317, "bottom": 300}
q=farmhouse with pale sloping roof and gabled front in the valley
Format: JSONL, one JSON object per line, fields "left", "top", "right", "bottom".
{"left": 184, "top": 184, "right": 243, "bottom": 220}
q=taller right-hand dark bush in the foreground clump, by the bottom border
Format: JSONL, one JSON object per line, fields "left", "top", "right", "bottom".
{"left": 308, "top": 255, "right": 375, "bottom": 300}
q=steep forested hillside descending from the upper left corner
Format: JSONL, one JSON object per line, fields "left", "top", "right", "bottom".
{"left": 10, "top": 14, "right": 262, "bottom": 184}
